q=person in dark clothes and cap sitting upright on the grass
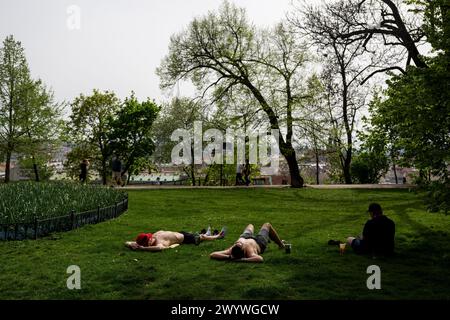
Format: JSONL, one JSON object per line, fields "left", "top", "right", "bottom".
{"left": 328, "top": 203, "right": 395, "bottom": 256}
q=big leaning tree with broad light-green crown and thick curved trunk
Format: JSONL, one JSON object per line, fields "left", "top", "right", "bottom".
{"left": 158, "top": 2, "right": 312, "bottom": 187}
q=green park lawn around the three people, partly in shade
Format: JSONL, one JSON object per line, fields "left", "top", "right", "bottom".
{"left": 0, "top": 188, "right": 450, "bottom": 300}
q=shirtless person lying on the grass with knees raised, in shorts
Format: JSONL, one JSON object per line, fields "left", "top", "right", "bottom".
{"left": 210, "top": 222, "right": 284, "bottom": 262}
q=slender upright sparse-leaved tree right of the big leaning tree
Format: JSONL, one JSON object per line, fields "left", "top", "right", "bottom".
{"left": 290, "top": 0, "right": 396, "bottom": 184}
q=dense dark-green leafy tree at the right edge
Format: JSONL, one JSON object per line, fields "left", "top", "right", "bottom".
{"left": 362, "top": 0, "right": 450, "bottom": 211}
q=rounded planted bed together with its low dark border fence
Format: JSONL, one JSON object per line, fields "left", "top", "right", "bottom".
{"left": 0, "top": 182, "right": 128, "bottom": 240}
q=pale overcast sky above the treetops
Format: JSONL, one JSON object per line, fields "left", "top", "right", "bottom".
{"left": 0, "top": 0, "right": 306, "bottom": 107}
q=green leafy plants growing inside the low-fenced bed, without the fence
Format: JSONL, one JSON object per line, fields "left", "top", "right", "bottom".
{"left": 0, "top": 182, "right": 126, "bottom": 223}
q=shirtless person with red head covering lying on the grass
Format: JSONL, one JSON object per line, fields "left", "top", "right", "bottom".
{"left": 125, "top": 227, "right": 226, "bottom": 251}
